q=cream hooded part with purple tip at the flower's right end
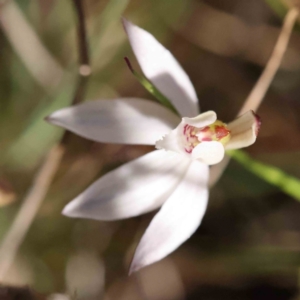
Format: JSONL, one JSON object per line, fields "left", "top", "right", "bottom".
{"left": 225, "top": 110, "right": 261, "bottom": 150}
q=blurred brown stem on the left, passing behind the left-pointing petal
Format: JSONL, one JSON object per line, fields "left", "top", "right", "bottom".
{"left": 0, "top": 0, "right": 91, "bottom": 281}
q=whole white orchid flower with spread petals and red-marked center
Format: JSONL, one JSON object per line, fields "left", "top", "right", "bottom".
{"left": 48, "top": 20, "right": 259, "bottom": 272}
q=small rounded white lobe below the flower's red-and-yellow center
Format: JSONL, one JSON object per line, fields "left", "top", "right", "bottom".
{"left": 192, "top": 141, "right": 225, "bottom": 165}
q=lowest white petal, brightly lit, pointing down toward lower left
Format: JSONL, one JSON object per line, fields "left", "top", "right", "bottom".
{"left": 130, "top": 161, "right": 209, "bottom": 272}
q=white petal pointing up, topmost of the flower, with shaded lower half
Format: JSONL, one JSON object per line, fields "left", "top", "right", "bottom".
{"left": 123, "top": 19, "right": 199, "bottom": 117}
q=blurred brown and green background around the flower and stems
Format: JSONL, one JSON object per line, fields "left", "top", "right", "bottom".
{"left": 0, "top": 0, "right": 300, "bottom": 300}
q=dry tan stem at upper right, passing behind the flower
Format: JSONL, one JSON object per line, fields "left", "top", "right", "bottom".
{"left": 209, "top": 8, "right": 299, "bottom": 187}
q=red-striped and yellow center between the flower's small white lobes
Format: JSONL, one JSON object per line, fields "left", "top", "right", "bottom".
{"left": 183, "top": 120, "right": 230, "bottom": 153}
